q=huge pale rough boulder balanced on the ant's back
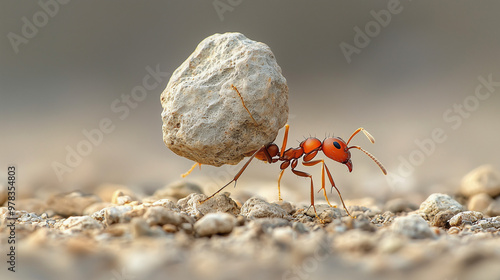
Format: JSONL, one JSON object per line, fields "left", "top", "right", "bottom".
{"left": 161, "top": 33, "right": 288, "bottom": 166}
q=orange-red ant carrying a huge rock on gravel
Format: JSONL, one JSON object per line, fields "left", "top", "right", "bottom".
{"left": 183, "top": 85, "right": 387, "bottom": 220}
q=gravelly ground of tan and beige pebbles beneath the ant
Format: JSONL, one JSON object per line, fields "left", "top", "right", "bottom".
{"left": 0, "top": 166, "right": 500, "bottom": 280}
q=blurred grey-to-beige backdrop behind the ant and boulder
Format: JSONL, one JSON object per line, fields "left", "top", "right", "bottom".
{"left": 0, "top": 0, "right": 500, "bottom": 201}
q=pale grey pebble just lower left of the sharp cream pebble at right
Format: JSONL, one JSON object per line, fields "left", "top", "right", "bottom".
{"left": 392, "top": 214, "right": 434, "bottom": 239}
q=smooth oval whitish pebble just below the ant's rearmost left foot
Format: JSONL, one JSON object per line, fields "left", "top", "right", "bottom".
{"left": 194, "top": 213, "right": 236, "bottom": 237}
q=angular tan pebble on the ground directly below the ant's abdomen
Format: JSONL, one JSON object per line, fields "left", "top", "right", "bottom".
{"left": 241, "top": 197, "right": 289, "bottom": 219}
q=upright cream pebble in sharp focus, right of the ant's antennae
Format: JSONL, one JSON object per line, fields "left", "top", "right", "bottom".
{"left": 419, "top": 193, "right": 465, "bottom": 220}
